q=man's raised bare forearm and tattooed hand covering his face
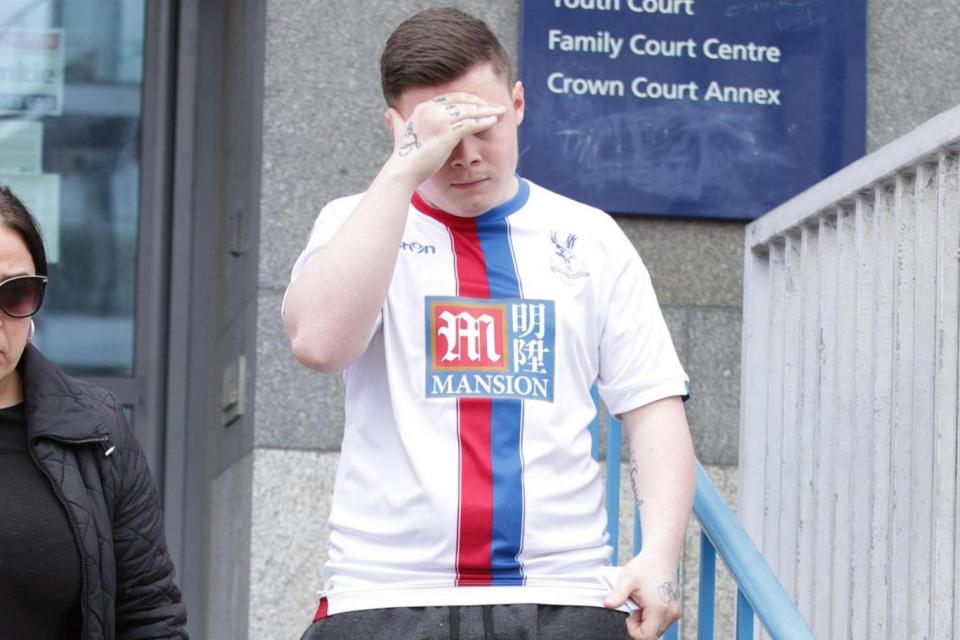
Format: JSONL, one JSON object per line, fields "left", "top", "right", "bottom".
{"left": 284, "top": 92, "right": 506, "bottom": 373}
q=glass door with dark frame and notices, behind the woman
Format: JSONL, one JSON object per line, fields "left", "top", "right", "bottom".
{"left": 0, "top": 0, "right": 172, "bottom": 478}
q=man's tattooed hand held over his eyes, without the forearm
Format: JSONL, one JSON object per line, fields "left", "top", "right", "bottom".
{"left": 384, "top": 92, "right": 507, "bottom": 188}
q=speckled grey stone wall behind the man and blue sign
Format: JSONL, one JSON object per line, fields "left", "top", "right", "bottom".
{"left": 201, "top": 0, "right": 960, "bottom": 640}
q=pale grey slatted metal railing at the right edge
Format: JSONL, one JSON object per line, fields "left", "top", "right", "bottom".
{"left": 740, "top": 106, "right": 960, "bottom": 638}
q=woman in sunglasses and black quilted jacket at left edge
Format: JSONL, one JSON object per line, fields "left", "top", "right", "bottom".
{"left": 0, "top": 187, "right": 187, "bottom": 640}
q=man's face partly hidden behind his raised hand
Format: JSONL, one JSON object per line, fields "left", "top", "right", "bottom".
{"left": 395, "top": 63, "right": 524, "bottom": 217}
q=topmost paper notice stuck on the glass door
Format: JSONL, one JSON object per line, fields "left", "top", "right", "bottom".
{"left": 0, "top": 28, "right": 64, "bottom": 117}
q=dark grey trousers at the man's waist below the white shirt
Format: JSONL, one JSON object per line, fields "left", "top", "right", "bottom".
{"left": 300, "top": 604, "right": 629, "bottom": 640}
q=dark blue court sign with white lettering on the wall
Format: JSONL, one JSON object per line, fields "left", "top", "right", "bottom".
{"left": 520, "top": 0, "right": 866, "bottom": 220}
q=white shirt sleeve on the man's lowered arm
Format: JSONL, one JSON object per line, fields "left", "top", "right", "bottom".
{"left": 597, "top": 227, "right": 690, "bottom": 415}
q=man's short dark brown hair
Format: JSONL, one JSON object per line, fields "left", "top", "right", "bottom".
{"left": 380, "top": 7, "right": 513, "bottom": 105}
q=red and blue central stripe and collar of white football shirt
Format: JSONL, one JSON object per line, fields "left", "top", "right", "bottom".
{"left": 413, "top": 180, "right": 530, "bottom": 586}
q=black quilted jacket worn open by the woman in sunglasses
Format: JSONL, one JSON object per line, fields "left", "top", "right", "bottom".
{"left": 18, "top": 345, "right": 187, "bottom": 640}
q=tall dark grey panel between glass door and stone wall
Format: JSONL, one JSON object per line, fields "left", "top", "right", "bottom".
{"left": 197, "top": 0, "right": 265, "bottom": 638}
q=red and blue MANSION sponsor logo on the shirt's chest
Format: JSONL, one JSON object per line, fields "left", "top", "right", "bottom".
{"left": 425, "top": 296, "right": 555, "bottom": 402}
